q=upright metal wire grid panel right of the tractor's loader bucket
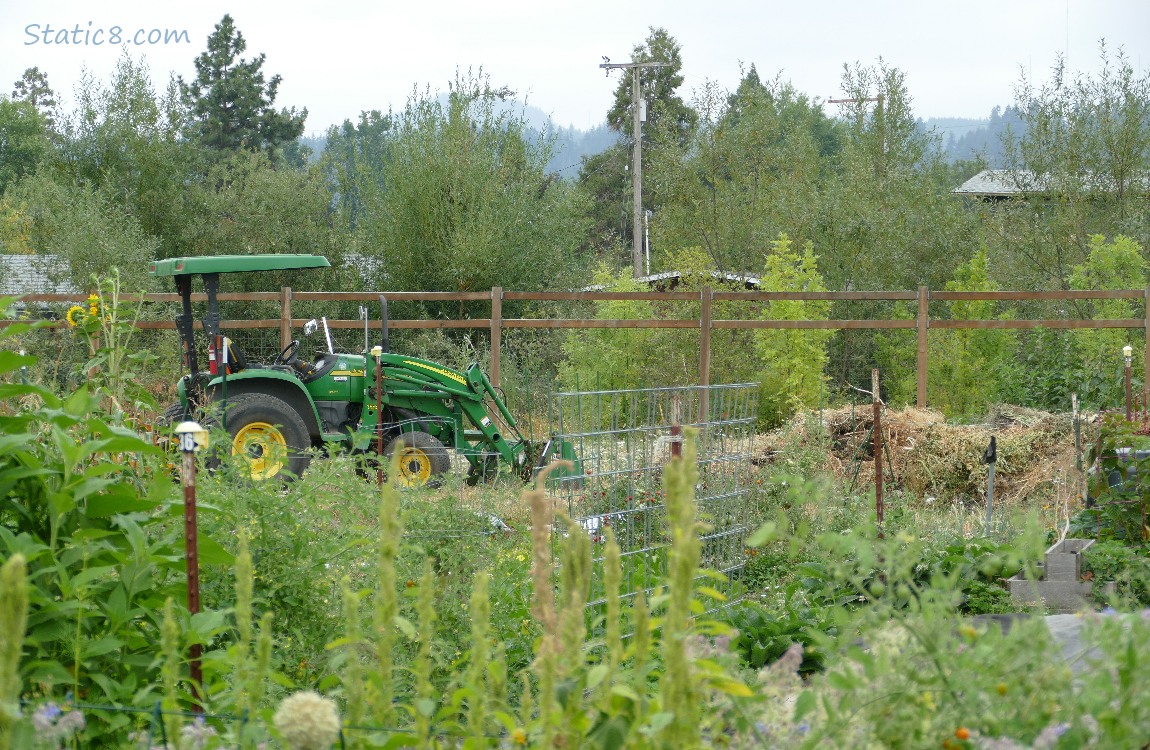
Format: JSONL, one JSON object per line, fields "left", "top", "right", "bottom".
{"left": 551, "top": 383, "right": 759, "bottom": 619}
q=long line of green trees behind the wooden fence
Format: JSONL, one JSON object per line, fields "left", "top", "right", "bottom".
{"left": 0, "top": 16, "right": 1150, "bottom": 421}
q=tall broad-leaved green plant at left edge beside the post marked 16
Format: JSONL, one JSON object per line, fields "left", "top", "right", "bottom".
{"left": 0, "top": 303, "right": 183, "bottom": 742}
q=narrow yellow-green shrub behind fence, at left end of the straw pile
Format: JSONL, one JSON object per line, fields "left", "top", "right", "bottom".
{"left": 756, "top": 235, "right": 831, "bottom": 426}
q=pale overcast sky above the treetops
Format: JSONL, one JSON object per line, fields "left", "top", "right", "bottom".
{"left": 0, "top": 0, "right": 1150, "bottom": 133}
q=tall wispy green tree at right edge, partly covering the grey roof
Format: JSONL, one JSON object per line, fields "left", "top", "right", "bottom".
{"left": 994, "top": 40, "right": 1150, "bottom": 284}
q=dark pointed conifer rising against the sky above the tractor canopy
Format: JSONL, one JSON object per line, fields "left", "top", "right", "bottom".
{"left": 179, "top": 15, "right": 307, "bottom": 155}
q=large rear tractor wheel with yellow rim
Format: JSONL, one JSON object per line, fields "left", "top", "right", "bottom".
{"left": 213, "top": 393, "right": 312, "bottom": 482}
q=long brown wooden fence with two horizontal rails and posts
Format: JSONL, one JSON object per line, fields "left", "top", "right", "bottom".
{"left": 8, "top": 286, "right": 1150, "bottom": 407}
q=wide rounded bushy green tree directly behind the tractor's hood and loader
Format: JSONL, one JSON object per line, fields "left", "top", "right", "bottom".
{"left": 337, "top": 72, "right": 587, "bottom": 316}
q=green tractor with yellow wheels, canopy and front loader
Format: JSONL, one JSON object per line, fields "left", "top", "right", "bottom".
{"left": 155, "top": 254, "right": 581, "bottom": 485}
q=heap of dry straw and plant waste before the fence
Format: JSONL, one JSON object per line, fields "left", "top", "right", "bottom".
{"left": 753, "top": 404, "right": 1081, "bottom": 502}
